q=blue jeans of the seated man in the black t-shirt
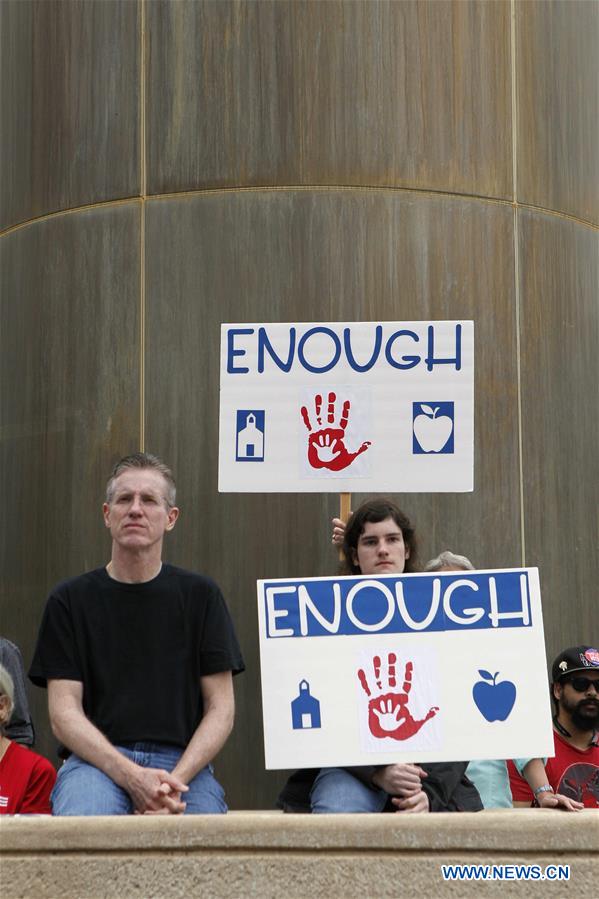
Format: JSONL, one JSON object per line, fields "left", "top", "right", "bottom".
{"left": 50, "top": 743, "right": 227, "bottom": 815}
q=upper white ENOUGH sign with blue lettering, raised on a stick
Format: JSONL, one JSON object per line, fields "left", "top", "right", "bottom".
{"left": 219, "top": 321, "right": 474, "bottom": 493}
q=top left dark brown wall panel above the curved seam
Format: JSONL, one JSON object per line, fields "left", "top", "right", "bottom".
{"left": 0, "top": 0, "right": 140, "bottom": 229}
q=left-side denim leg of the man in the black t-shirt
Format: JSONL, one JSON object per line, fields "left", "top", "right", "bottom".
{"left": 50, "top": 750, "right": 133, "bottom": 816}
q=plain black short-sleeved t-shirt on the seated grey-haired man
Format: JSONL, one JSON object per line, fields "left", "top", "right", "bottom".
{"left": 29, "top": 565, "right": 245, "bottom": 747}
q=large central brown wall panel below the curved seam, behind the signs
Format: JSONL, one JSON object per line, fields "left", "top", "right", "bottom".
{"left": 146, "top": 191, "right": 520, "bottom": 808}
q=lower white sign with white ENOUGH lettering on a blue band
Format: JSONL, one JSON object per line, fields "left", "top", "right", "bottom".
{"left": 258, "top": 568, "right": 553, "bottom": 769}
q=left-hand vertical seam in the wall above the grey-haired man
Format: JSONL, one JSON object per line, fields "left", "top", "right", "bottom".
{"left": 139, "top": 0, "right": 146, "bottom": 452}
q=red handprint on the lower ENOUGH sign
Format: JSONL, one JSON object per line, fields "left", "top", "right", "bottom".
{"left": 358, "top": 652, "right": 439, "bottom": 740}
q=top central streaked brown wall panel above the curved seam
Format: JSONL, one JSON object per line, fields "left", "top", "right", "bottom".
{"left": 147, "top": 0, "right": 512, "bottom": 198}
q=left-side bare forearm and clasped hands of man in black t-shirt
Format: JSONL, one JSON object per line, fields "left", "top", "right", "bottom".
{"left": 48, "top": 679, "right": 187, "bottom": 813}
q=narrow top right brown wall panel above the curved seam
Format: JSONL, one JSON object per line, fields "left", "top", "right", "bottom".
{"left": 517, "top": 0, "right": 599, "bottom": 223}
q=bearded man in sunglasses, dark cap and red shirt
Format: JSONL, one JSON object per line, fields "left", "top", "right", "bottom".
{"left": 508, "top": 646, "right": 599, "bottom": 808}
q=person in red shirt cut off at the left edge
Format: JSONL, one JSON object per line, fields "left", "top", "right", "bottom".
{"left": 0, "top": 665, "right": 56, "bottom": 815}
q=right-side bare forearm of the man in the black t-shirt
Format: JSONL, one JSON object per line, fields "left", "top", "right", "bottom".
{"left": 173, "top": 671, "right": 235, "bottom": 784}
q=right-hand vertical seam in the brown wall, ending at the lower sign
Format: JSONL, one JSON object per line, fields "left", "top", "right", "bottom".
{"left": 510, "top": 0, "right": 526, "bottom": 566}
